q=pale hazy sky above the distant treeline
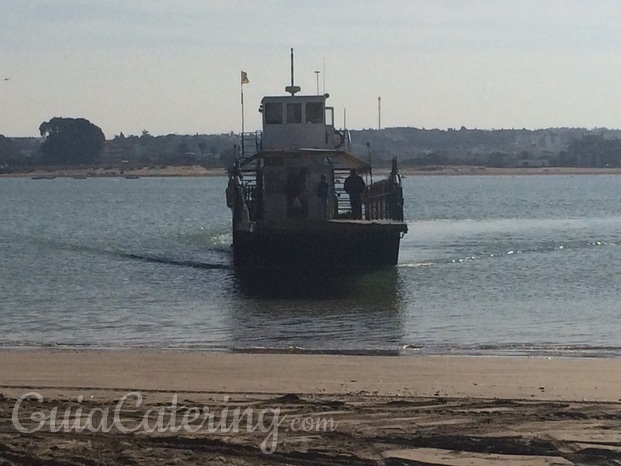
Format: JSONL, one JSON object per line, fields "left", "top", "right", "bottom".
{"left": 0, "top": 0, "right": 621, "bottom": 139}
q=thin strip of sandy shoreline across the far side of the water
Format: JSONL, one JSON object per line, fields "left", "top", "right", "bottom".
{"left": 0, "top": 165, "right": 621, "bottom": 179}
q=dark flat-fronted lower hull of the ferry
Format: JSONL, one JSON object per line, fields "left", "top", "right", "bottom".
{"left": 233, "top": 221, "right": 407, "bottom": 272}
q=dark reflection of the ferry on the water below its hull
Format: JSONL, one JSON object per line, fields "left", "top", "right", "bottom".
{"left": 228, "top": 268, "right": 405, "bottom": 355}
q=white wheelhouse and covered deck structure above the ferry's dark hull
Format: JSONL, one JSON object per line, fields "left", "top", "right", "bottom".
{"left": 231, "top": 91, "right": 402, "bottom": 223}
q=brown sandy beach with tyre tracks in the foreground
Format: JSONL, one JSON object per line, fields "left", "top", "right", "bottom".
{"left": 0, "top": 350, "right": 621, "bottom": 466}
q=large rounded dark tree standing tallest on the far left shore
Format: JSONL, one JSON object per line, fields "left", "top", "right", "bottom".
{"left": 39, "top": 117, "right": 106, "bottom": 165}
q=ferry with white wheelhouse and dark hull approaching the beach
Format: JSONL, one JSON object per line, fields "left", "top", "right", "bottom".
{"left": 226, "top": 51, "right": 407, "bottom": 273}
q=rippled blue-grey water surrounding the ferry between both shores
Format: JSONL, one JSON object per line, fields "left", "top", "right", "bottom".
{"left": 0, "top": 175, "right": 621, "bottom": 357}
